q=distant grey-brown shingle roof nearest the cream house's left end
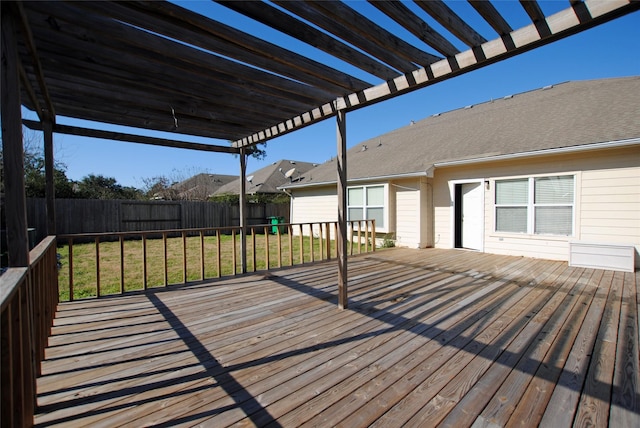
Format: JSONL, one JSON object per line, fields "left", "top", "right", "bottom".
{"left": 216, "top": 159, "right": 317, "bottom": 195}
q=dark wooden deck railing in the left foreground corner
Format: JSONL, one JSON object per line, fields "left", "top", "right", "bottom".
{"left": 0, "top": 236, "right": 58, "bottom": 427}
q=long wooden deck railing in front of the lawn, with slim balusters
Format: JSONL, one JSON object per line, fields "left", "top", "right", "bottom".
{"left": 58, "top": 220, "right": 376, "bottom": 300}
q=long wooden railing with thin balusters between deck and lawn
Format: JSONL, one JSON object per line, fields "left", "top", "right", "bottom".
{"left": 59, "top": 220, "right": 375, "bottom": 300}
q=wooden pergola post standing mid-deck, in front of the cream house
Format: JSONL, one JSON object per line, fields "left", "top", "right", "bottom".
{"left": 336, "top": 110, "right": 348, "bottom": 309}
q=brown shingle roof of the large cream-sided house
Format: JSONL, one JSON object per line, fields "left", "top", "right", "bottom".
{"left": 283, "top": 76, "right": 640, "bottom": 188}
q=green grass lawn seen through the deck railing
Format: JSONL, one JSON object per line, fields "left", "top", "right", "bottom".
{"left": 58, "top": 234, "right": 364, "bottom": 301}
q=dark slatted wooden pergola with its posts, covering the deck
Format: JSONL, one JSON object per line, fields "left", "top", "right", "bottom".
{"left": 1, "top": 0, "right": 640, "bottom": 308}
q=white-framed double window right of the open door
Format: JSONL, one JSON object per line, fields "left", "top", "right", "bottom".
{"left": 495, "top": 175, "right": 575, "bottom": 236}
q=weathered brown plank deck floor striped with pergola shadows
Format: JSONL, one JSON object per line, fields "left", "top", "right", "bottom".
{"left": 36, "top": 249, "right": 640, "bottom": 427}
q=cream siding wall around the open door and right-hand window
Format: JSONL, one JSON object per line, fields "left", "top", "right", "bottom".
{"left": 434, "top": 147, "right": 640, "bottom": 266}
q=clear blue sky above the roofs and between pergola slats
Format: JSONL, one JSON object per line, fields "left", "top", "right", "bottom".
{"left": 17, "top": 1, "right": 640, "bottom": 188}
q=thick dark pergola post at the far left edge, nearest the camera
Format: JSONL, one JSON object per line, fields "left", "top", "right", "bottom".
{"left": 0, "top": 5, "right": 29, "bottom": 267}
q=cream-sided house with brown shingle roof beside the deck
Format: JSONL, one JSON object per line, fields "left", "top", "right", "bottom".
{"left": 284, "top": 76, "right": 640, "bottom": 267}
